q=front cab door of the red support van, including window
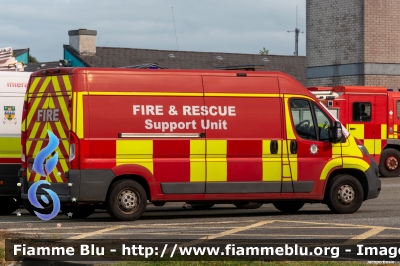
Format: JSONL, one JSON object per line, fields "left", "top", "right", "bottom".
{"left": 285, "top": 97, "right": 334, "bottom": 195}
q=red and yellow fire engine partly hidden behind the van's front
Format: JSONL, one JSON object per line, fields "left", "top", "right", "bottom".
{"left": 309, "top": 86, "right": 400, "bottom": 177}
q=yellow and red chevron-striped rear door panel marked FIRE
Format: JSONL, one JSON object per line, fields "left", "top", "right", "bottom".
{"left": 25, "top": 75, "right": 71, "bottom": 183}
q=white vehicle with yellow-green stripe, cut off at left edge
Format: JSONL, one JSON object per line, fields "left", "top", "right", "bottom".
{"left": 0, "top": 71, "right": 31, "bottom": 214}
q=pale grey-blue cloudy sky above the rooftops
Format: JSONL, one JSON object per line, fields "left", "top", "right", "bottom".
{"left": 0, "top": 0, "right": 306, "bottom": 62}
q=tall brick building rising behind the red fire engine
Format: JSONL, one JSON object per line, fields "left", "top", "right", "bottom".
{"left": 306, "top": 0, "right": 400, "bottom": 88}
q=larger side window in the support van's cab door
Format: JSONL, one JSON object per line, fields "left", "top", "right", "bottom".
{"left": 290, "top": 99, "right": 317, "bottom": 140}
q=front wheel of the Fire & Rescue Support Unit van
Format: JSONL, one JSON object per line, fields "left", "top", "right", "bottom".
{"left": 325, "top": 175, "right": 364, "bottom": 213}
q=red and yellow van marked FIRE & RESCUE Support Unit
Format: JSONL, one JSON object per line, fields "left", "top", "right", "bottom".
{"left": 19, "top": 68, "right": 381, "bottom": 220}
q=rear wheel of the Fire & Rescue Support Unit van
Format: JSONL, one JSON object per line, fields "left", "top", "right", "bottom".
{"left": 106, "top": 179, "right": 147, "bottom": 221}
